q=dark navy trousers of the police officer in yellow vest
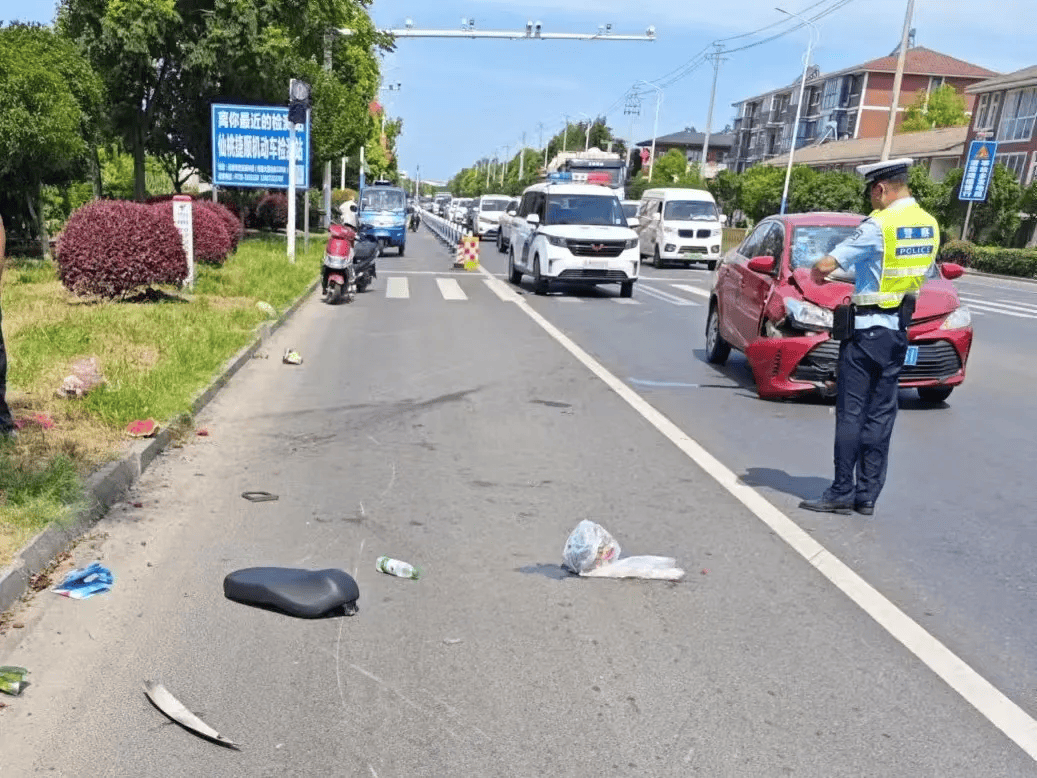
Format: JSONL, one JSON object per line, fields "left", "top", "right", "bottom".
{"left": 826, "top": 327, "right": 907, "bottom": 503}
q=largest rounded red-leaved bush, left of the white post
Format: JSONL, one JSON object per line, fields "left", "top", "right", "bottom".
{"left": 57, "top": 200, "right": 188, "bottom": 298}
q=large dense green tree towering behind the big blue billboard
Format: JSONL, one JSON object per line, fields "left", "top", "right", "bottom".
{"left": 58, "top": 0, "right": 391, "bottom": 198}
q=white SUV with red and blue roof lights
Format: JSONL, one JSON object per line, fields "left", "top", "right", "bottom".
{"left": 508, "top": 182, "right": 641, "bottom": 297}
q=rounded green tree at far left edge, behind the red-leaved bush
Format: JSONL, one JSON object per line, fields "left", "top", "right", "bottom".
{"left": 0, "top": 24, "right": 103, "bottom": 252}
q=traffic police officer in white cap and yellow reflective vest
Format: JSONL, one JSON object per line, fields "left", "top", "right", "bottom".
{"left": 800, "top": 159, "right": 940, "bottom": 516}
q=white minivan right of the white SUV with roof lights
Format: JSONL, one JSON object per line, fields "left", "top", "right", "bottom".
{"left": 637, "top": 187, "right": 727, "bottom": 270}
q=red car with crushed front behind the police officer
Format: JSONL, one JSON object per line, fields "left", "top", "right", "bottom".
{"left": 706, "top": 214, "right": 973, "bottom": 402}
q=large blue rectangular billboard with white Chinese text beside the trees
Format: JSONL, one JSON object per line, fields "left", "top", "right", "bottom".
{"left": 212, "top": 103, "right": 310, "bottom": 189}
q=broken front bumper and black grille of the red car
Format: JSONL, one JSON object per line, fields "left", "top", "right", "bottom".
{"left": 746, "top": 322, "right": 973, "bottom": 399}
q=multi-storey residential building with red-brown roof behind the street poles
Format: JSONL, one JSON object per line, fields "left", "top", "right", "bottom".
{"left": 731, "top": 47, "right": 998, "bottom": 171}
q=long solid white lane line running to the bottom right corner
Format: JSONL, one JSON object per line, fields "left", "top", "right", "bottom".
{"left": 474, "top": 265, "right": 1037, "bottom": 760}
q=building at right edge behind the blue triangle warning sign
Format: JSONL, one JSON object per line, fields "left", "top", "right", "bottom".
{"left": 961, "top": 65, "right": 1037, "bottom": 187}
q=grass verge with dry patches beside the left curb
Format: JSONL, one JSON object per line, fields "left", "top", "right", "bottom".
{"left": 0, "top": 237, "right": 324, "bottom": 566}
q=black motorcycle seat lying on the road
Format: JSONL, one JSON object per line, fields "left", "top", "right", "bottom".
{"left": 223, "top": 567, "right": 360, "bottom": 618}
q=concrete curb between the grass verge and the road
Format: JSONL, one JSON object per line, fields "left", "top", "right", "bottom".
{"left": 0, "top": 279, "right": 320, "bottom": 613}
